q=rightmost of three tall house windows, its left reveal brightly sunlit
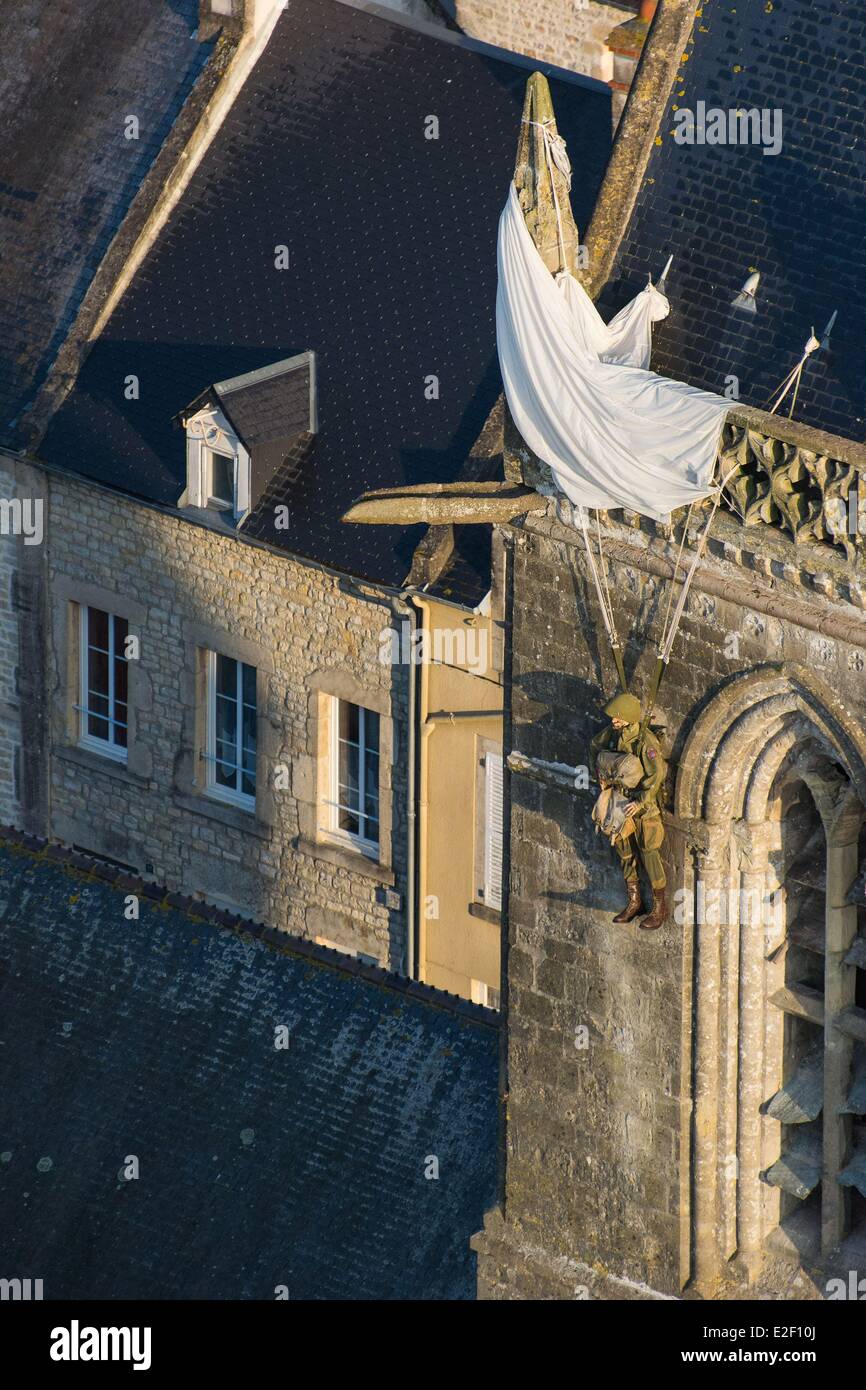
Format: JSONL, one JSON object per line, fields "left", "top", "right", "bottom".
{"left": 328, "top": 696, "right": 379, "bottom": 859}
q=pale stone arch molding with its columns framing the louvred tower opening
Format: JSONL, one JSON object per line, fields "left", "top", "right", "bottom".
{"left": 674, "top": 663, "right": 866, "bottom": 1295}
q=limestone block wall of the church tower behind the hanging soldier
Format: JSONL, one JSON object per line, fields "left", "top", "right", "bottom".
{"left": 474, "top": 509, "right": 866, "bottom": 1298}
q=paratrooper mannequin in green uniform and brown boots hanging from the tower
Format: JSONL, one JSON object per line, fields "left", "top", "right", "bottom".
{"left": 591, "top": 695, "right": 667, "bottom": 930}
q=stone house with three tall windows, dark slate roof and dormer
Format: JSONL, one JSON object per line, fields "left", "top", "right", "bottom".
{"left": 0, "top": 0, "right": 609, "bottom": 1004}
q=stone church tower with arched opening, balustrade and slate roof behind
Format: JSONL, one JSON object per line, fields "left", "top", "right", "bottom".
{"left": 473, "top": 0, "right": 866, "bottom": 1300}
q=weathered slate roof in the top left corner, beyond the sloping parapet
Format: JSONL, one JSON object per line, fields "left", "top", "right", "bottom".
{"left": 0, "top": 0, "right": 211, "bottom": 443}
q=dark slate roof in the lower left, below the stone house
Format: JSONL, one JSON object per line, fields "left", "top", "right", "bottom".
{"left": 0, "top": 845, "right": 498, "bottom": 1300}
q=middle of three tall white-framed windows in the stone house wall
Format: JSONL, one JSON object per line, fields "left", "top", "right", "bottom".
{"left": 204, "top": 652, "right": 257, "bottom": 810}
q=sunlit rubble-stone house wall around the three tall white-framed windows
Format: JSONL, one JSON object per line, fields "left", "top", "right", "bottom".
{"left": 35, "top": 474, "right": 407, "bottom": 969}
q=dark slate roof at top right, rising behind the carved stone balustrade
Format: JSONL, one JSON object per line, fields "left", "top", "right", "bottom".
{"left": 601, "top": 0, "right": 866, "bottom": 441}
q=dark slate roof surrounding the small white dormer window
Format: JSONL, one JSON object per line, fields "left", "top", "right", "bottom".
{"left": 40, "top": 0, "right": 610, "bottom": 584}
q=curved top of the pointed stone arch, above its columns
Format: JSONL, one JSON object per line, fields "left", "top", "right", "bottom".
{"left": 674, "top": 664, "right": 866, "bottom": 828}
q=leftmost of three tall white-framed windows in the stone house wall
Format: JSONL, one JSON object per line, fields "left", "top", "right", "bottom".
{"left": 75, "top": 605, "right": 129, "bottom": 763}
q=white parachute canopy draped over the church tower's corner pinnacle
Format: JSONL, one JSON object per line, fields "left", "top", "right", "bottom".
{"left": 496, "top": 183, "right": 730, "bottom": 520}
